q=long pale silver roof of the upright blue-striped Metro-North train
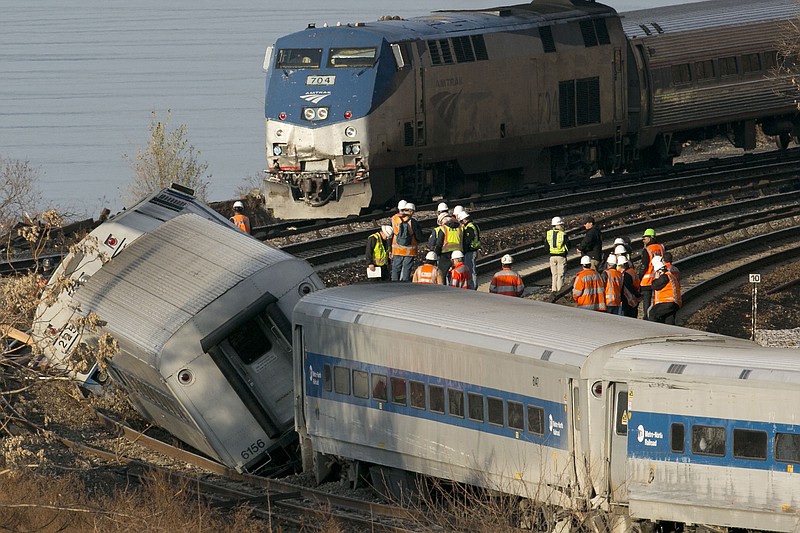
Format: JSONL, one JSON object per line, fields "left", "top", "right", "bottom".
{"left": 295, "top": 283, "right": 800, "bottom": 381}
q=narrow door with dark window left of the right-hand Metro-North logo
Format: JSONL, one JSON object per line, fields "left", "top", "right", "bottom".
{"left": 607, "top": 382, "right": 629, "bottom": 502}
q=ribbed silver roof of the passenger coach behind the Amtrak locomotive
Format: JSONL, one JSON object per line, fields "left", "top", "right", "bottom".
{"left": 620, "top": 0, "right": 800, "bottom": 39}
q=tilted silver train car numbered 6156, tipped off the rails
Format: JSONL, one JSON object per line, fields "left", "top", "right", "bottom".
{"left": 30, "top": 187, "right": 323, "bottom": 472}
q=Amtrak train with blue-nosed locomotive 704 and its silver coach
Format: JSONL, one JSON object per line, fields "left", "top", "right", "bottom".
{"left": 264, "top": 0, "right": 798, "bottom": 218}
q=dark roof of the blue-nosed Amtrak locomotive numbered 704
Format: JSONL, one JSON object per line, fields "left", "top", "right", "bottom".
{"left": 281, "top": 0, "right": 616, "bottom": 42}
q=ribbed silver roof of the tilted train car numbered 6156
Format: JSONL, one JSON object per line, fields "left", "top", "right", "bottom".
{"left": 75, "top": 214, "right": 294, "bottom": 355}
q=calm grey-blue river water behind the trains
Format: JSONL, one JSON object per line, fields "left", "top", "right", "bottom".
{"left": 0, "top": 0, "right": 692, "bottom": 216}
